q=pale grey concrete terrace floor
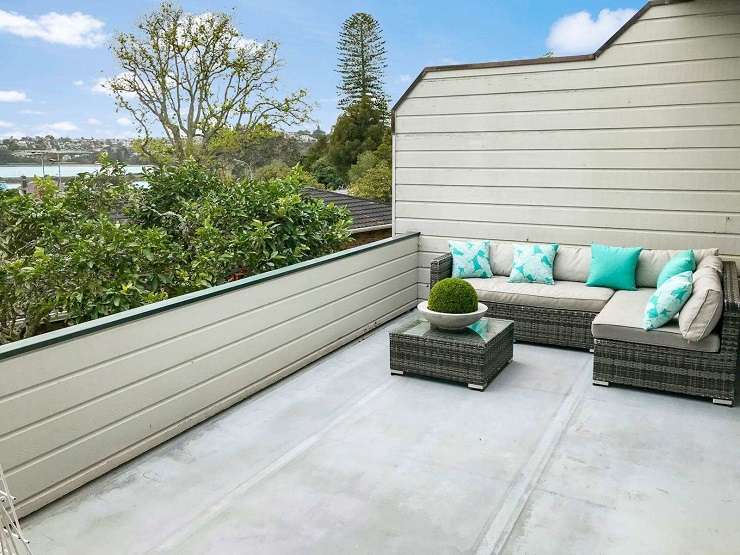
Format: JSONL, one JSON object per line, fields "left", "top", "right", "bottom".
{"left": 23, "top": 315, "right": 740, "bottom": 555}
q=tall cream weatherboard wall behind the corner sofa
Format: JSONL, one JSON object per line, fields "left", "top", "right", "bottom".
{"left": 394, "top": 0, "right": 740, "bottom": 297}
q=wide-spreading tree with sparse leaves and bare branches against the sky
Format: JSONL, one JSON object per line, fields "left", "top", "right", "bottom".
{"left": 104, "top": 2, "right": 309, "bottom": 160}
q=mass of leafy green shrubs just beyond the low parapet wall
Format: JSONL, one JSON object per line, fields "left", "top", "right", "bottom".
{"left": 0, "top": 156, "right": 350, "bottom": 343}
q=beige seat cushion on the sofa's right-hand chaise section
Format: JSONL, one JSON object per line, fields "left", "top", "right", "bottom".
{"left": 591, "top": 289, "right": 719, "bottom": 353}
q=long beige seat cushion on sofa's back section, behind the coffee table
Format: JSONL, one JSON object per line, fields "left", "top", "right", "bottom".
{"left": 465, "top": 276, "right": 614, "bottom": 312}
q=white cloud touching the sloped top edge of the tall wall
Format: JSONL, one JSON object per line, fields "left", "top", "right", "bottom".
{"left": 547, "top": 8, "right": 636, "bottom": 55}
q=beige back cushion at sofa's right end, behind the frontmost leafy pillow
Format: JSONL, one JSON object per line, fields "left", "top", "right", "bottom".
{"left": 678, "top": 267, "right": 724, "bottom": 341}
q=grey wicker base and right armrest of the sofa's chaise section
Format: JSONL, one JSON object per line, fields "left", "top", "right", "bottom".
{"left": 594, "top": 262, "right": 740, "bottom": 405}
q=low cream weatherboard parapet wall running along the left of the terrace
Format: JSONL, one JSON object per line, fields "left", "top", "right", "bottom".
{"left": 0, "top": 235, "right": 418, "bottom": 514}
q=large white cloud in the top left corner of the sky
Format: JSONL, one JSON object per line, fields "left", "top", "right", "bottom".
{"left": 0, "top": 10, "right": 105, "bottom": 48}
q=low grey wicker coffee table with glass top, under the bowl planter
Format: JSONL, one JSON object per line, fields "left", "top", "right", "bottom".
{"left": 390, "top": 318, "right": 514, "bottom": 391}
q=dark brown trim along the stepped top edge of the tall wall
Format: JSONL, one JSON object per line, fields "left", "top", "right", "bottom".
{"left": 391, "top": 0, "right": 693, "bottom": 131}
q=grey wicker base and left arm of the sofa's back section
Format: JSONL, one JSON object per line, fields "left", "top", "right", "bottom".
{"left": 429, "top": 253, "right": 597, "bottom": 349}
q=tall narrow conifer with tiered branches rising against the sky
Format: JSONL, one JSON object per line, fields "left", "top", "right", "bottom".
{"left": 337, "top": 12, "right": 388, "bottom": 113}
